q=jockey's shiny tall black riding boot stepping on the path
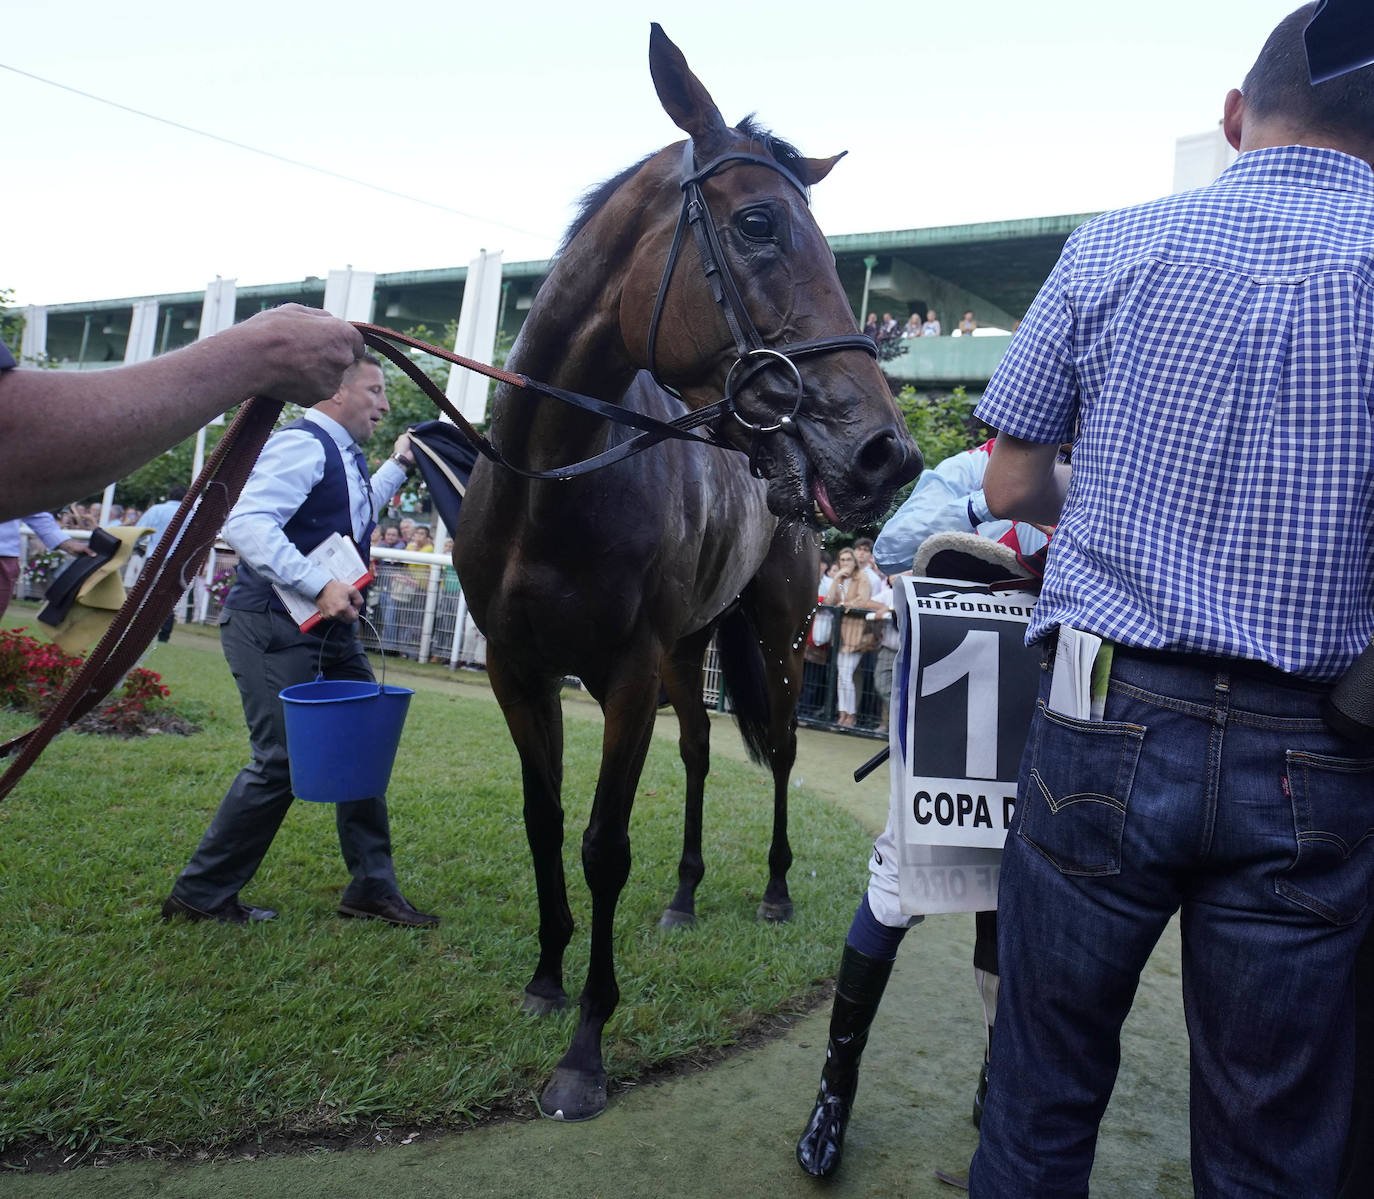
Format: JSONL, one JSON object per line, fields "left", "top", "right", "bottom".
{"left": 797, "top": 944, "right": 892, "bottom": 1178}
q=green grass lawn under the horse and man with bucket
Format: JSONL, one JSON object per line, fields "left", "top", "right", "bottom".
{"left": 0, "top": 608, "right": 867, "bottom": 1152}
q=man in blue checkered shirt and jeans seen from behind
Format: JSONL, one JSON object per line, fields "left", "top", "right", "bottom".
{"left": 973, "top": 5, "right": 1374, "bottom": 1199}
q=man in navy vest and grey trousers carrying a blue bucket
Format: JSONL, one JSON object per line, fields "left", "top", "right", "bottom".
{"left": 162, "top": 356, "right": 438, "bottom": 927}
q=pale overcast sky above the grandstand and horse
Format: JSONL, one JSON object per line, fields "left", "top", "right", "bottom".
{"left": 0, "top": 0, "right": 1296, "bottom": 304}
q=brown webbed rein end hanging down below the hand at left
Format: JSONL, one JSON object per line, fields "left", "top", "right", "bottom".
{"left": 0, "top": 396, "right": 282, "bottom": 799}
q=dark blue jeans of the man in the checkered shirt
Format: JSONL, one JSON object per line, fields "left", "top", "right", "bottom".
{"left": 971, "top": 651, "right": 1374, "bottom": 1199}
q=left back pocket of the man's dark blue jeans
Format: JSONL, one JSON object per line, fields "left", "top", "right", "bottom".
{"left": 1017, "top": 700, "right": 1145, "bottom": 875}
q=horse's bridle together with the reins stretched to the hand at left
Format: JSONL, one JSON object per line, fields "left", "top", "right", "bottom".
{"left": 354, "top": 140, "right": 878, "bottom": 479}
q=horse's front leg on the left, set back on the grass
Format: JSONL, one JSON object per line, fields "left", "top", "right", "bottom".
{"left": 486, "top": 646, "right": 573, "bottom": 1015}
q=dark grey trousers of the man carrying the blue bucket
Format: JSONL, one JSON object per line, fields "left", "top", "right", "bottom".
{"left": 172, "top": 610, "right": 397, "bottom": 911}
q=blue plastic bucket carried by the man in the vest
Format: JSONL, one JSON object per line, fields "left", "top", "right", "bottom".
{"left": 282, "top": 678, "right": 415, "bottom": 803}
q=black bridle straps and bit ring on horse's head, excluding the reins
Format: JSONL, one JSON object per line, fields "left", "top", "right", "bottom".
{"left": 647, "top": 140, "right": 878, "bottom": 458}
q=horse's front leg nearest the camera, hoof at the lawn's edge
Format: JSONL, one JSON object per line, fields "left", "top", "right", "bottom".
{"left": 539, "top": 659, "right": 658, "bottom": 1119}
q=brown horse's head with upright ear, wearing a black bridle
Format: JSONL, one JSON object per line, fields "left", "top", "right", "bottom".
{"left": 620, "top": 25, "right": 922, "bottom": 527}
